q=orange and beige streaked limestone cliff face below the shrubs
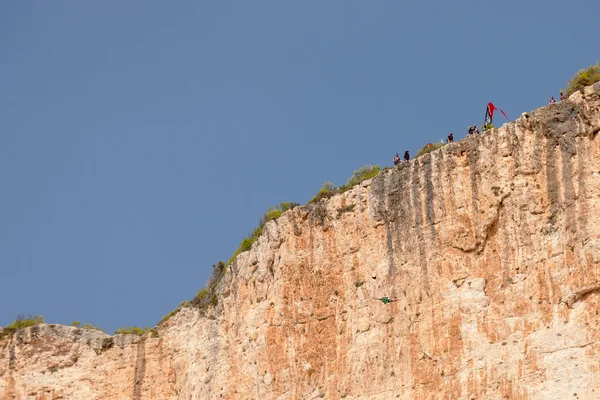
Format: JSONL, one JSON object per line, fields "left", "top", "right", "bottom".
{"left": 0, "top": 83, "right": 600, "bottom": 400}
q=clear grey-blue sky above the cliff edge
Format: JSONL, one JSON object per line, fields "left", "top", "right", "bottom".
{"left": 0, "top": 0, "right": 600, "bottom": 332}
